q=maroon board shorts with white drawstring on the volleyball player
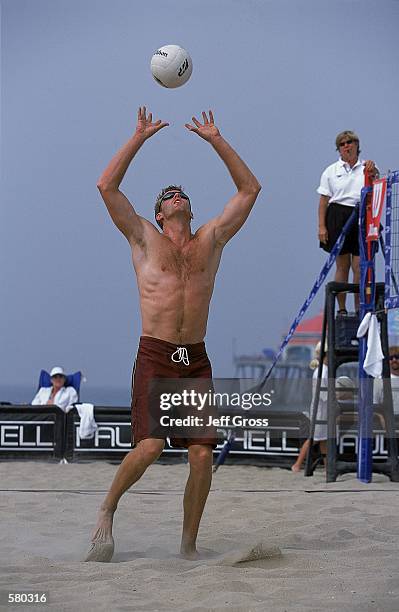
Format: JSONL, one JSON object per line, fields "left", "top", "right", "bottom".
{"left": 131, "top": 336, "right": 217, "bottom": 448}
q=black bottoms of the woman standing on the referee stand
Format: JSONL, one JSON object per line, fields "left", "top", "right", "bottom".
{"left": 320, "top": 202, "right": 359, "bottom": 255}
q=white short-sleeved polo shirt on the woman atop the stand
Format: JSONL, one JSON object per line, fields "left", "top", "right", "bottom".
{"left": 317, "top": 158, "right": 365, "bottom": 207}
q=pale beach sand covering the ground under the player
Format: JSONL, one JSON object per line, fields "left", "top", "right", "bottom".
{"left": 0, "top": 462, "right": 399, "bottom": 612}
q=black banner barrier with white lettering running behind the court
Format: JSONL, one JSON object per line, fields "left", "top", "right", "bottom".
{"left": 0, "top": 396, "right": 399, "bottom": 467}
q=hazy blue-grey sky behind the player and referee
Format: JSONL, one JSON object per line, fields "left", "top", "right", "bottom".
{"left": 0, "top": 0, "right": 399, "bottom": 387}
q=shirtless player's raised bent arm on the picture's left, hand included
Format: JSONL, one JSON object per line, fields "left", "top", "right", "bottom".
{"left": 97, "top": 106, "right": 169, "bottom": 243}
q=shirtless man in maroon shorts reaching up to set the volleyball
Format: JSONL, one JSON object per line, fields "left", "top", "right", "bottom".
{"left": 86, "top": 107, "right": 261, "bottom": 561}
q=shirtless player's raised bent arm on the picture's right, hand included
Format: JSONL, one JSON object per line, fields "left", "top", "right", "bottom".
{"left": 186, "top": 111, "right": 261, "bottom": 244}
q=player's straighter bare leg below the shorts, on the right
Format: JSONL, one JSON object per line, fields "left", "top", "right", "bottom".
{"left": 180, "top": 444, "right": 212, "bottom": 559}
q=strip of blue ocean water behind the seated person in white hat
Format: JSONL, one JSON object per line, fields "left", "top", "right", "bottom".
{"left": 0, "top": 383, "right": 130, "bottom": 406}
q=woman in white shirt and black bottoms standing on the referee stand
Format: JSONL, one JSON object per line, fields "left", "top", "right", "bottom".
{"left": 317, "top": 130, "right": 378, "bottom": 315}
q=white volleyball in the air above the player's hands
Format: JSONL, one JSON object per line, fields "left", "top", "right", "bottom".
{"left": 151, "top": 45, "right": 193, "bottom": 88}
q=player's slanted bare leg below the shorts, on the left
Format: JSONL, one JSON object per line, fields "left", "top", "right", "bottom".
{"left": 86, "top": 438, "right": 165, "bottom": 561}
